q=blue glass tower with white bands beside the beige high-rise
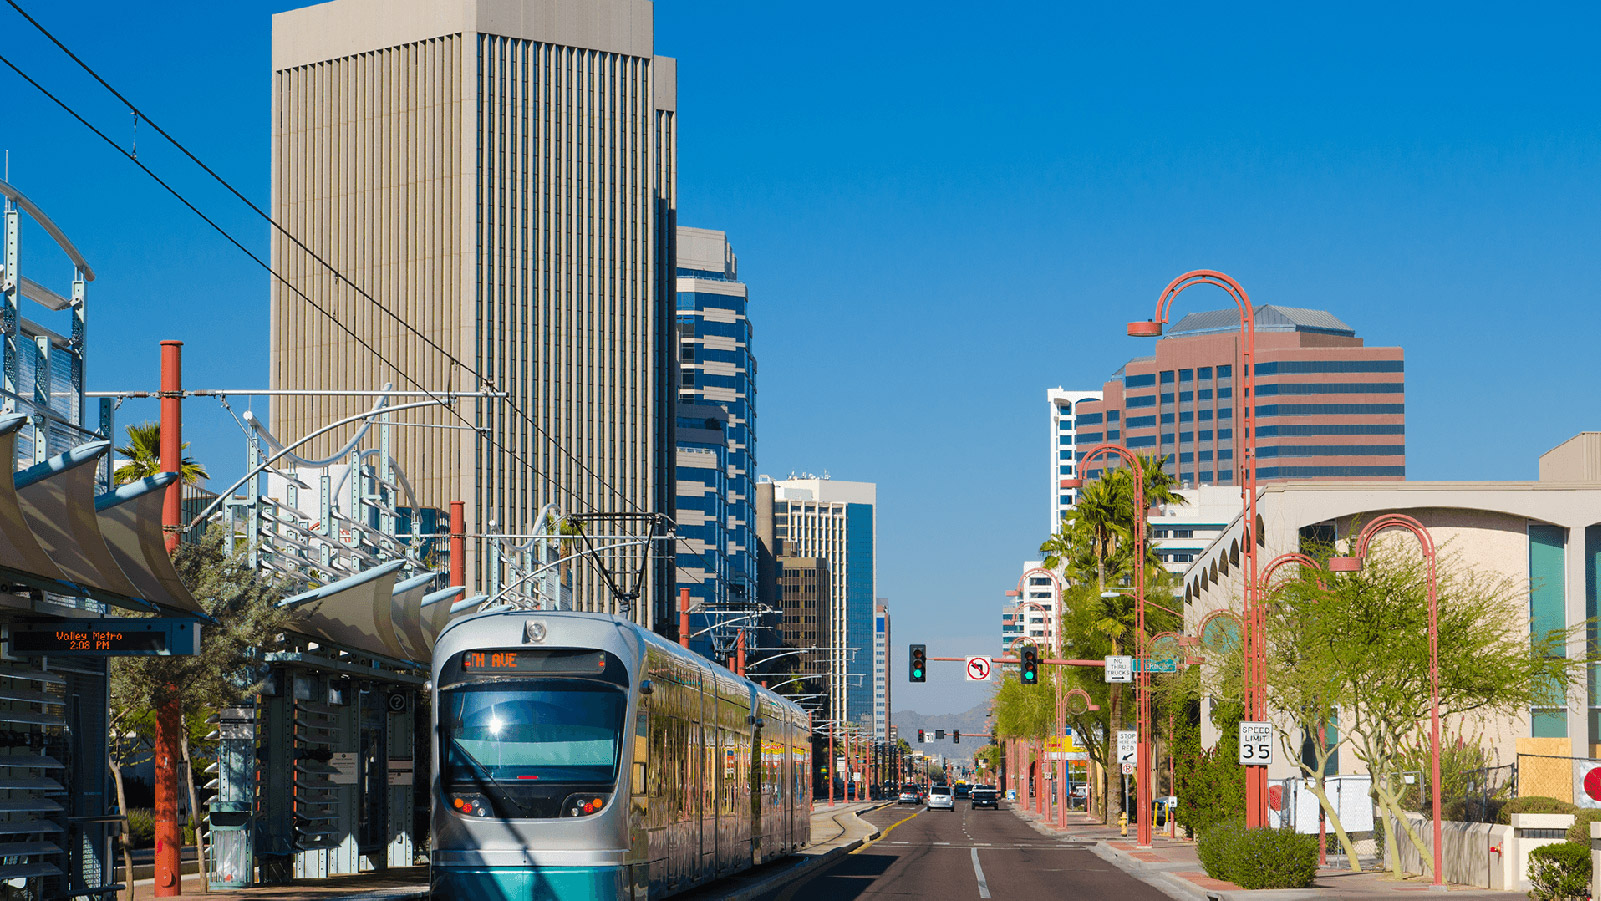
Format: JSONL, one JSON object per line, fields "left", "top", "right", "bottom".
{"left": 677, "top": 227, "right": 764, "bottom": 658}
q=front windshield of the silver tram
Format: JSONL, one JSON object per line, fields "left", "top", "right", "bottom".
{"left": 451, "top": 679, "right": 628, "bottom": 787}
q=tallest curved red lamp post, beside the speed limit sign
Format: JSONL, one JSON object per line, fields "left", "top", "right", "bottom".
{"left": 1129, "top": 269, "right": 1268, "bottom": 827}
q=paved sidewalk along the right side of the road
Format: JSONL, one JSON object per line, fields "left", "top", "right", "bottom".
{"left": 1007, "top": 803, "right": 1524, "bottom": 901}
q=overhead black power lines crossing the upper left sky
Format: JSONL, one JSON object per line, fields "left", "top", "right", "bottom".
{"left": 5, "top": 0, "right": 645, "bottom": 512}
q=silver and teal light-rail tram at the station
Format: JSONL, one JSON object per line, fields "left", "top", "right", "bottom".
{"left": 429, "top": 611, "right": 812, "bottom": 901}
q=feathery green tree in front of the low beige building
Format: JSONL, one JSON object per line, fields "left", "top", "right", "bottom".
{"left": 1266, "top": 541, "right": 1595, "bottom": 867}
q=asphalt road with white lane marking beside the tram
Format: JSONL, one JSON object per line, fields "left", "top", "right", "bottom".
{"left": 760, "top": 800, "right": 1167, "bottom": 901}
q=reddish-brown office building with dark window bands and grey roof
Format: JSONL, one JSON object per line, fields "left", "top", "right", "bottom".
{"left": 1074, "top": 304, "right": 1406, "bottom": 487}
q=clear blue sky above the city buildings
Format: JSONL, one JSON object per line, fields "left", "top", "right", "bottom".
{"left": 0, "top": 0, "right": 1601, "bottom": 712}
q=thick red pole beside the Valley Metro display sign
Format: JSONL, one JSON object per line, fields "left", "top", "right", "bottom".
{"left": 152, "top": 341, "right": 184, "bottom": 898}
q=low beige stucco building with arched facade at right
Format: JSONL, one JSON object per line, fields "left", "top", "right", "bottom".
{"left": 1183, "top": 432, "right": 1601, "bottom": 797}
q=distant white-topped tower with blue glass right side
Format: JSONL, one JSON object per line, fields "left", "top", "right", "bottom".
{"left": 773, "top": 479, "right": 877, "bottom": 727}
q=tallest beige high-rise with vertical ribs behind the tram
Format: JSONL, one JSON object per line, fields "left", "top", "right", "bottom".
{"left": 271, "top": 0, "right": 677, "bottom": 624}
